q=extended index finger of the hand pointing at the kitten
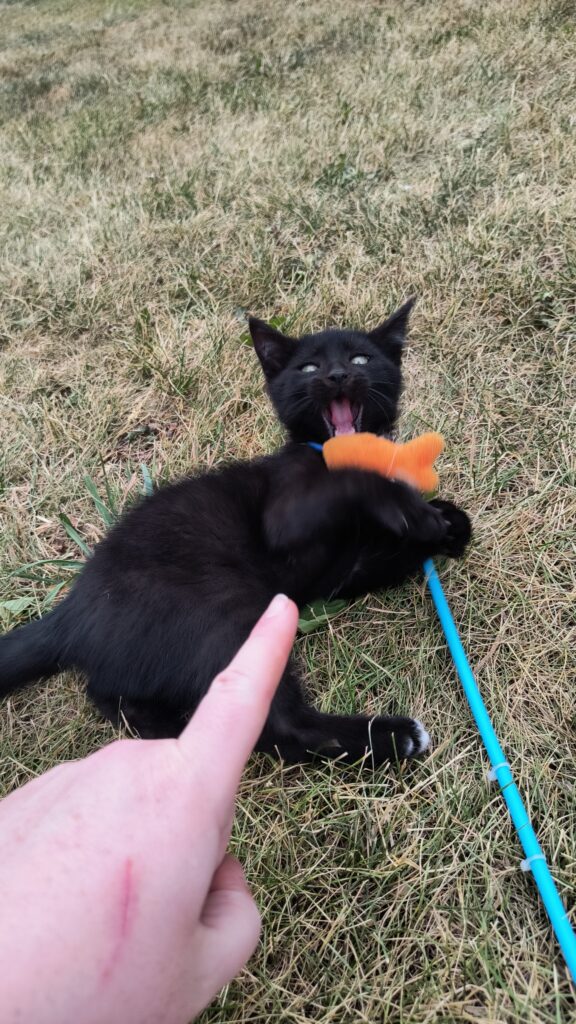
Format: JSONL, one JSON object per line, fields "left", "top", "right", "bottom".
{"left": 179, "top": 594, "right": 298, "bottom": 802}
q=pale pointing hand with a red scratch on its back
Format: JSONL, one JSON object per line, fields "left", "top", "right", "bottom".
{"left": 0, "top": 596, "right": 297, "bottom": 1024}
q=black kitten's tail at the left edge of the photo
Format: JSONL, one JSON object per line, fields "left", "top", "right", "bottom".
{"left": 0, "top": 601, "right": 67, "bottom": 697}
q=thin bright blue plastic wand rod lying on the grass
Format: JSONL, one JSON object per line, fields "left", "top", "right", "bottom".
{"left": 424, "top": 558, "right": 576, "bottom": 981}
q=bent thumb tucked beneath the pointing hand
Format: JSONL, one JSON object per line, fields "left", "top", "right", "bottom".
{"left": 195, "top": 854, "right": 261, "bottom": 993}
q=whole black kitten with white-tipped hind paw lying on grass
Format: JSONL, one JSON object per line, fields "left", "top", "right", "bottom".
{"left": 0, "top": 302, "right": 470, "bottom": 764}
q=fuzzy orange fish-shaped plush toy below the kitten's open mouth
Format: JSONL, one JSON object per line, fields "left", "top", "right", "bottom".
{"left": 322, "top": 433, "right": 444, "bottom": 492}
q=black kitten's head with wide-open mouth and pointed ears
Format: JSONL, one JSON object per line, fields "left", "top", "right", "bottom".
{"left": 249, "top": 299, "right": 414, "bottom": 442}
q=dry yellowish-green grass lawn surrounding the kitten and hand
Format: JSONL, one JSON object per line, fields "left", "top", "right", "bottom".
{"left": 0, "top": 0, "right": 576, "bottom": 1024}
